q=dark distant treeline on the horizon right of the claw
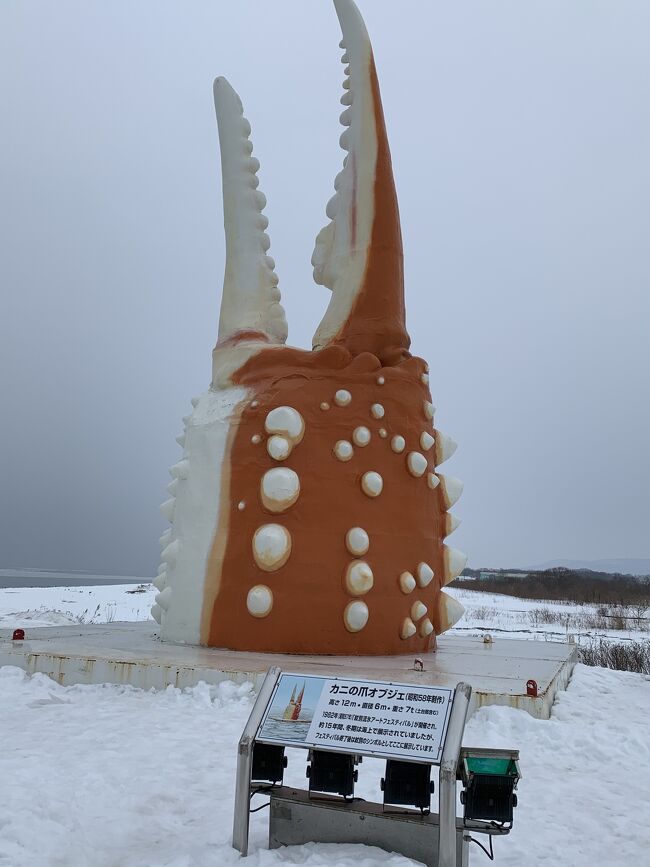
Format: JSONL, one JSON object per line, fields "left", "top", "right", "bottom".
{"left": 452, "top": 566, "right": 650, "bottom": 605}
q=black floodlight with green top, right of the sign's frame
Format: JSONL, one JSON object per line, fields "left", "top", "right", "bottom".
{"left": 458, "top": 747, "right": 521, "bottom": 824}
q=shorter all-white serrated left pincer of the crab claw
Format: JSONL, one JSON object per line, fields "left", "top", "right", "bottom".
{"left": 214, "top": 78, "right": 287, "bottom": 343}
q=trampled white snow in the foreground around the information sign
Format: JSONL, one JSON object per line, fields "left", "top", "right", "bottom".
{"left": 0, "top": 665, "right": 650, "bottom": 867}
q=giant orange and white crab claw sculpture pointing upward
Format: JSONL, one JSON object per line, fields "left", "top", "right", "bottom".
{"left": 153, "top": 0, "right": 466, "bottom": 654}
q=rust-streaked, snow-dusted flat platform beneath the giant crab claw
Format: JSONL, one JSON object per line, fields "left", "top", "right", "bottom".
{"left": 0, "top": 621, "right": 577, "bottom": 719}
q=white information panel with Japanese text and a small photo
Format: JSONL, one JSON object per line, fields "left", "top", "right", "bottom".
{"left": 257, "top": 673, "right": 454, "bottom": 764}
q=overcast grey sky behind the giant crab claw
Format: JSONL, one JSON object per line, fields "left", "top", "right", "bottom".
{"left": 0, "top": 0, "right": 650, "bottom": 575}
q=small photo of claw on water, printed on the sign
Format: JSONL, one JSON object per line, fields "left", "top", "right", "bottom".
{"left": 258, "top": 674, "right": 324, "bottom": 742}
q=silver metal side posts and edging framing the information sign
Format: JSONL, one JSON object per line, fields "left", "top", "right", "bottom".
{"left": 232, "top": 666, "right": 472, "bottom": 867}
